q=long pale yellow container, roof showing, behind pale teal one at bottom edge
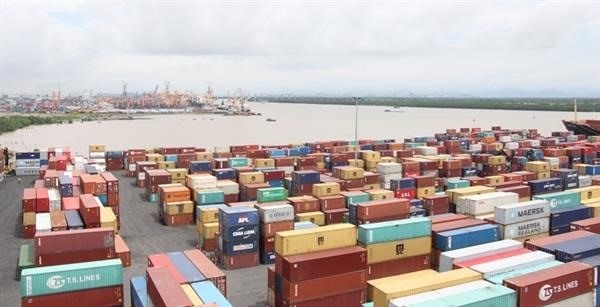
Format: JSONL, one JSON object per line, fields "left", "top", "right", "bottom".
{"left": 368, "top": 268, "right": 482, "bottom": 307}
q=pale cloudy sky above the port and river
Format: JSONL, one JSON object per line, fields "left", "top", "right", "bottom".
{"left": 0, "top": 0, "right": 600, "bottom": 97}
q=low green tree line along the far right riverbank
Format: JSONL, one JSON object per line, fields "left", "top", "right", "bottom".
{"left": 260, "top": 97, "right": 600, "bottom": 112}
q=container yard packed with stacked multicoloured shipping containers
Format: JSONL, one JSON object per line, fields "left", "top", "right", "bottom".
{"left": 0, "top": 127, "right": 600, "bottom": 307}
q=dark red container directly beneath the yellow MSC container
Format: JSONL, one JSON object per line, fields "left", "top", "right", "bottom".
{"left": 367, "top": 255, "right": 431, "bottom": 280}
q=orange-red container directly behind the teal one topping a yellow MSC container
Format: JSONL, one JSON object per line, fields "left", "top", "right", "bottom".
{"left": 356, "top": 198, "right": 410, "bottom": 220}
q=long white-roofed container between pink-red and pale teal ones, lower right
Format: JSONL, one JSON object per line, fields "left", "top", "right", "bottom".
{"left": 470, "top": 251, "right": 554, "bottom": 279}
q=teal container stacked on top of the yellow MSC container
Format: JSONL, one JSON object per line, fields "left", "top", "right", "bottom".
{"left": 358, "top": 217, "right": 431, "bottom": 245}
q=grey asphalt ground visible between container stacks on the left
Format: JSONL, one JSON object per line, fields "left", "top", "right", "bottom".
{"left": 0, "top": 172, "right": 267, "bottom": 307}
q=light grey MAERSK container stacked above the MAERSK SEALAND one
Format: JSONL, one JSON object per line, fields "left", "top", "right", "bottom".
{"left": 494, "top": 199, "right": 550, "bottom": 225}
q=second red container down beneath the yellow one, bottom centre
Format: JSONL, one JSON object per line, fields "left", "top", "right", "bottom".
{"left": 281, "top": 270, "right": 367, "bottom": 303}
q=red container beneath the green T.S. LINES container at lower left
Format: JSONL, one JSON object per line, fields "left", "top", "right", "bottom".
{"left": 21, "top": 285, "right": 124, "bottom": 307}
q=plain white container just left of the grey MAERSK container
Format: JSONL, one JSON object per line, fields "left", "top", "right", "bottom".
{"left": 456, "top": 192, "right": 519, "bottom": 215}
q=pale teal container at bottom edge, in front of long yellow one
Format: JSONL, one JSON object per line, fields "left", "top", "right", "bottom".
{"left": 408, "top": 285, "right": 517, "bottom": 307}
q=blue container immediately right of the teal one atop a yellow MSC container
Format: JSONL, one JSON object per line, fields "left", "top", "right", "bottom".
{"left": 435, "top": 224, "right": 500, "bottom": 251}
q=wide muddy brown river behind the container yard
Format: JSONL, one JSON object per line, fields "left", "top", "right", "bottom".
{"left": 0, "top": 103, "right": 580, "bottom": 155}
